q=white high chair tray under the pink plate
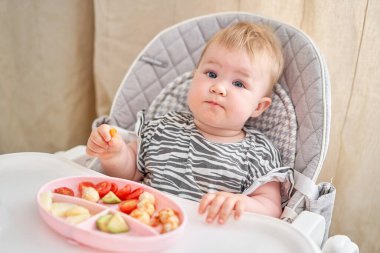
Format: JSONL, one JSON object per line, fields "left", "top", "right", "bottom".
{"left": 0, "top": 153, "right": 321, "bottom": 253}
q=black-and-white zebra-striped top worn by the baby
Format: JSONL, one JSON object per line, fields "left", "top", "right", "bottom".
{"left": 136, "top": 112, "right": 292, "bottom": 201}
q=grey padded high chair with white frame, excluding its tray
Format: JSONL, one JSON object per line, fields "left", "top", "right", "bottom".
{"left": 59, "top": 12, "right": 359, "bottom": 253}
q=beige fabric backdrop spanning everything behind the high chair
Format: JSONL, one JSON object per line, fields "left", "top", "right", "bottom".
{"left": 0, "top": 0, "right": 380, "bottom": 253}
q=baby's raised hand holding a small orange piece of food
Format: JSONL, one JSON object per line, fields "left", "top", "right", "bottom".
{"left": 86, "top": 124, "right": 124, "bottom": 159}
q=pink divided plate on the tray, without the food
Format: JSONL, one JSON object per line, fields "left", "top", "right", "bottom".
{"left": 37, "top": 176, "right": 187, "bottom": 252}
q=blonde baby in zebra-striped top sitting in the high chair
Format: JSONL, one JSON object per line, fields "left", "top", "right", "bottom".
{"left": 87, "top": 23, "right": 292, "bottom": 224}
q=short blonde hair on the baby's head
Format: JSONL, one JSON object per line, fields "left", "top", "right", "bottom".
{"left": 197, "top": 22, "right": 284, "bottom": 92}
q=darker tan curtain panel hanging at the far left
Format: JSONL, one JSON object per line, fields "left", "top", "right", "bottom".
{"left": 0, "top": 0, "right": 95, "bottom": 153}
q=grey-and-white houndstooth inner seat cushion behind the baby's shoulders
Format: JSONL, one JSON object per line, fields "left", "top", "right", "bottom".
{"left": 145, "top": 72, "right": 297, "bottom": 168}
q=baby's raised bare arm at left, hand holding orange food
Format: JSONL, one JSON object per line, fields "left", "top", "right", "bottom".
{"left": 86, "top": 124, "right": 142, "bottom": 181}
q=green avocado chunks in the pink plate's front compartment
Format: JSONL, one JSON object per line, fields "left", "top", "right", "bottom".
{"left": 96, "top": 213, "right": 129, "bottom": 234}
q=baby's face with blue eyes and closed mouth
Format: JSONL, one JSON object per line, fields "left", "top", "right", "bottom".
{"left": 188, "top": 43, "right": 269, "bottom": 130}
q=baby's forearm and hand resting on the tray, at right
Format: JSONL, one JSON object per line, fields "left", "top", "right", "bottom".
{"left": 199, "top": 182, "right": 282, "bottom": 224}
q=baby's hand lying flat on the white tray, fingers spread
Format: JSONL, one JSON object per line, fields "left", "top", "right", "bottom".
{"left": 199, "top": 192, "right": 244, "bottom": 224}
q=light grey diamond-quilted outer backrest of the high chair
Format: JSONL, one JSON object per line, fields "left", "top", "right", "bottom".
{"left": 110, "top": 12, "right": 330, "bottom": 181}
